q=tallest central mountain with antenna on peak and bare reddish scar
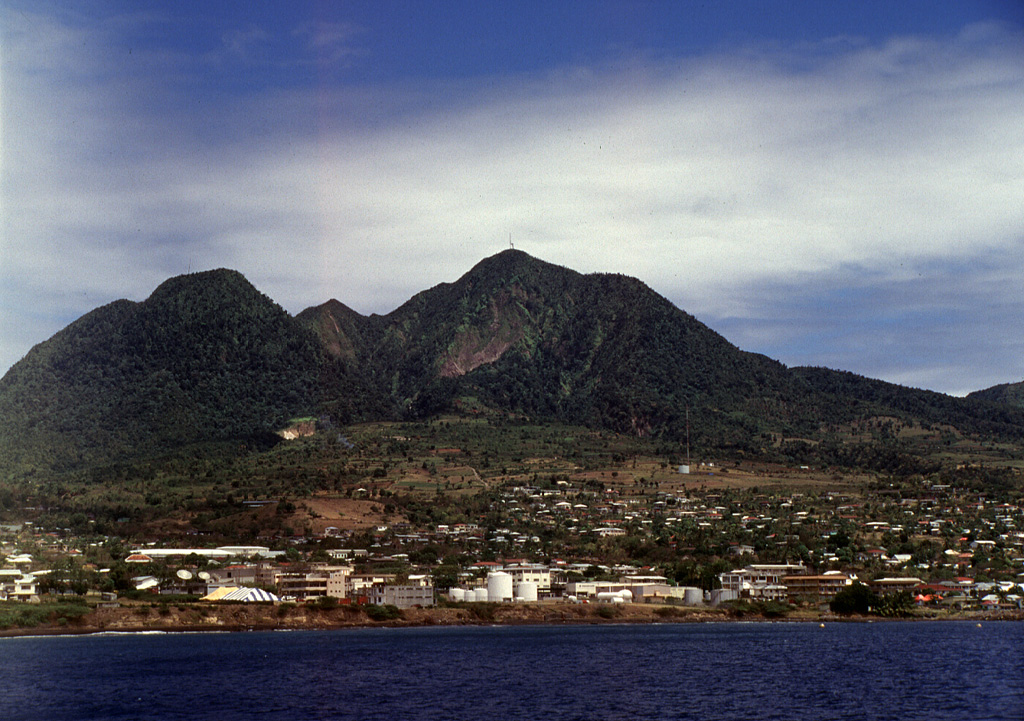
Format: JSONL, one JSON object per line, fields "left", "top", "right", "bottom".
{"left": 299, "top": 250, "right": 823, "bottom": 442}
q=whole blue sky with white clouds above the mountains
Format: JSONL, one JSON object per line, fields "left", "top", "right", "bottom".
{"left": 0, "top": 0, "right": 1024, "bottom": 394}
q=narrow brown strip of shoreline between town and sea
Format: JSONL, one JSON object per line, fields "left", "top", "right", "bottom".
{"left": 0, "top": 602, "right": 1024, "bottom": 638}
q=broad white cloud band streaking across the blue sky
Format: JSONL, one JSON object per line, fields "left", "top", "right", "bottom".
{"left": 0, "top": 11, "right": 1024, "bottom": 389}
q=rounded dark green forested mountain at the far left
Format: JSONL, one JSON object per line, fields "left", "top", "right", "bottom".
{"left": 0, "top": 270, "right": 324, "bottom": 470}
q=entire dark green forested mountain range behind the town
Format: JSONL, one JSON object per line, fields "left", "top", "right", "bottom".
{"left": 0, "top": 250, "right": 1024, "bottom": 477}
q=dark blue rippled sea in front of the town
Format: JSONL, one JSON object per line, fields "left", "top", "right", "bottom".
{"left": 0, "top": 622, "right": 1024, "bottom": 721}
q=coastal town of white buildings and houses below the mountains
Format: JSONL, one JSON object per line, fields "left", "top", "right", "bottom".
{"left": 0, "top": 413, "right": 1024, "bottom": 626}
